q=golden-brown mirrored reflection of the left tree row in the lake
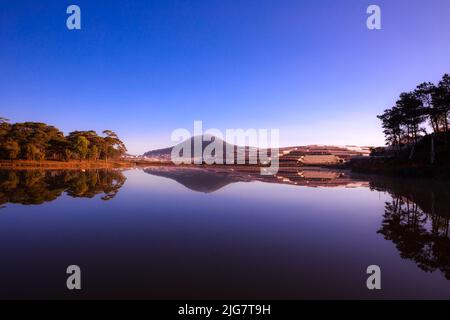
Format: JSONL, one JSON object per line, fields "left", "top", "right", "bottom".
{"left": 0, "top": 169, "right": 126, "bottom": 205}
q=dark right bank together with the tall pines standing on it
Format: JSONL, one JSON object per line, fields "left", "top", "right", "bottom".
{"left": 352, "top": 74, "right": 450, "bottom": 178}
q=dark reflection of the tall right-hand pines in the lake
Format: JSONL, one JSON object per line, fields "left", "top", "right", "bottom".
{"left": 378, "top": 183, "right": 450, "bottom": 280}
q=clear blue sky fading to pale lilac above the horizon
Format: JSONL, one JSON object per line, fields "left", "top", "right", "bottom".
{"left": 0, "top": 0, "right": 450, "bottom": 154}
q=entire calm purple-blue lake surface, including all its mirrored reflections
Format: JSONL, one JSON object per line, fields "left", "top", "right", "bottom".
{"left": 0, "top": 168, "right": 450, "bottom": 299}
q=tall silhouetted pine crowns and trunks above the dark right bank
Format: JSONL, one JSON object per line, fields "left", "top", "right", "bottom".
{"left": 378, "top": 74, "right": 450, "bottom": 149}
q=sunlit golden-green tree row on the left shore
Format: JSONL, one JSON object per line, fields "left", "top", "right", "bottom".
{"left": 0, "top": 117, "right": 127, "bottom": 161}
